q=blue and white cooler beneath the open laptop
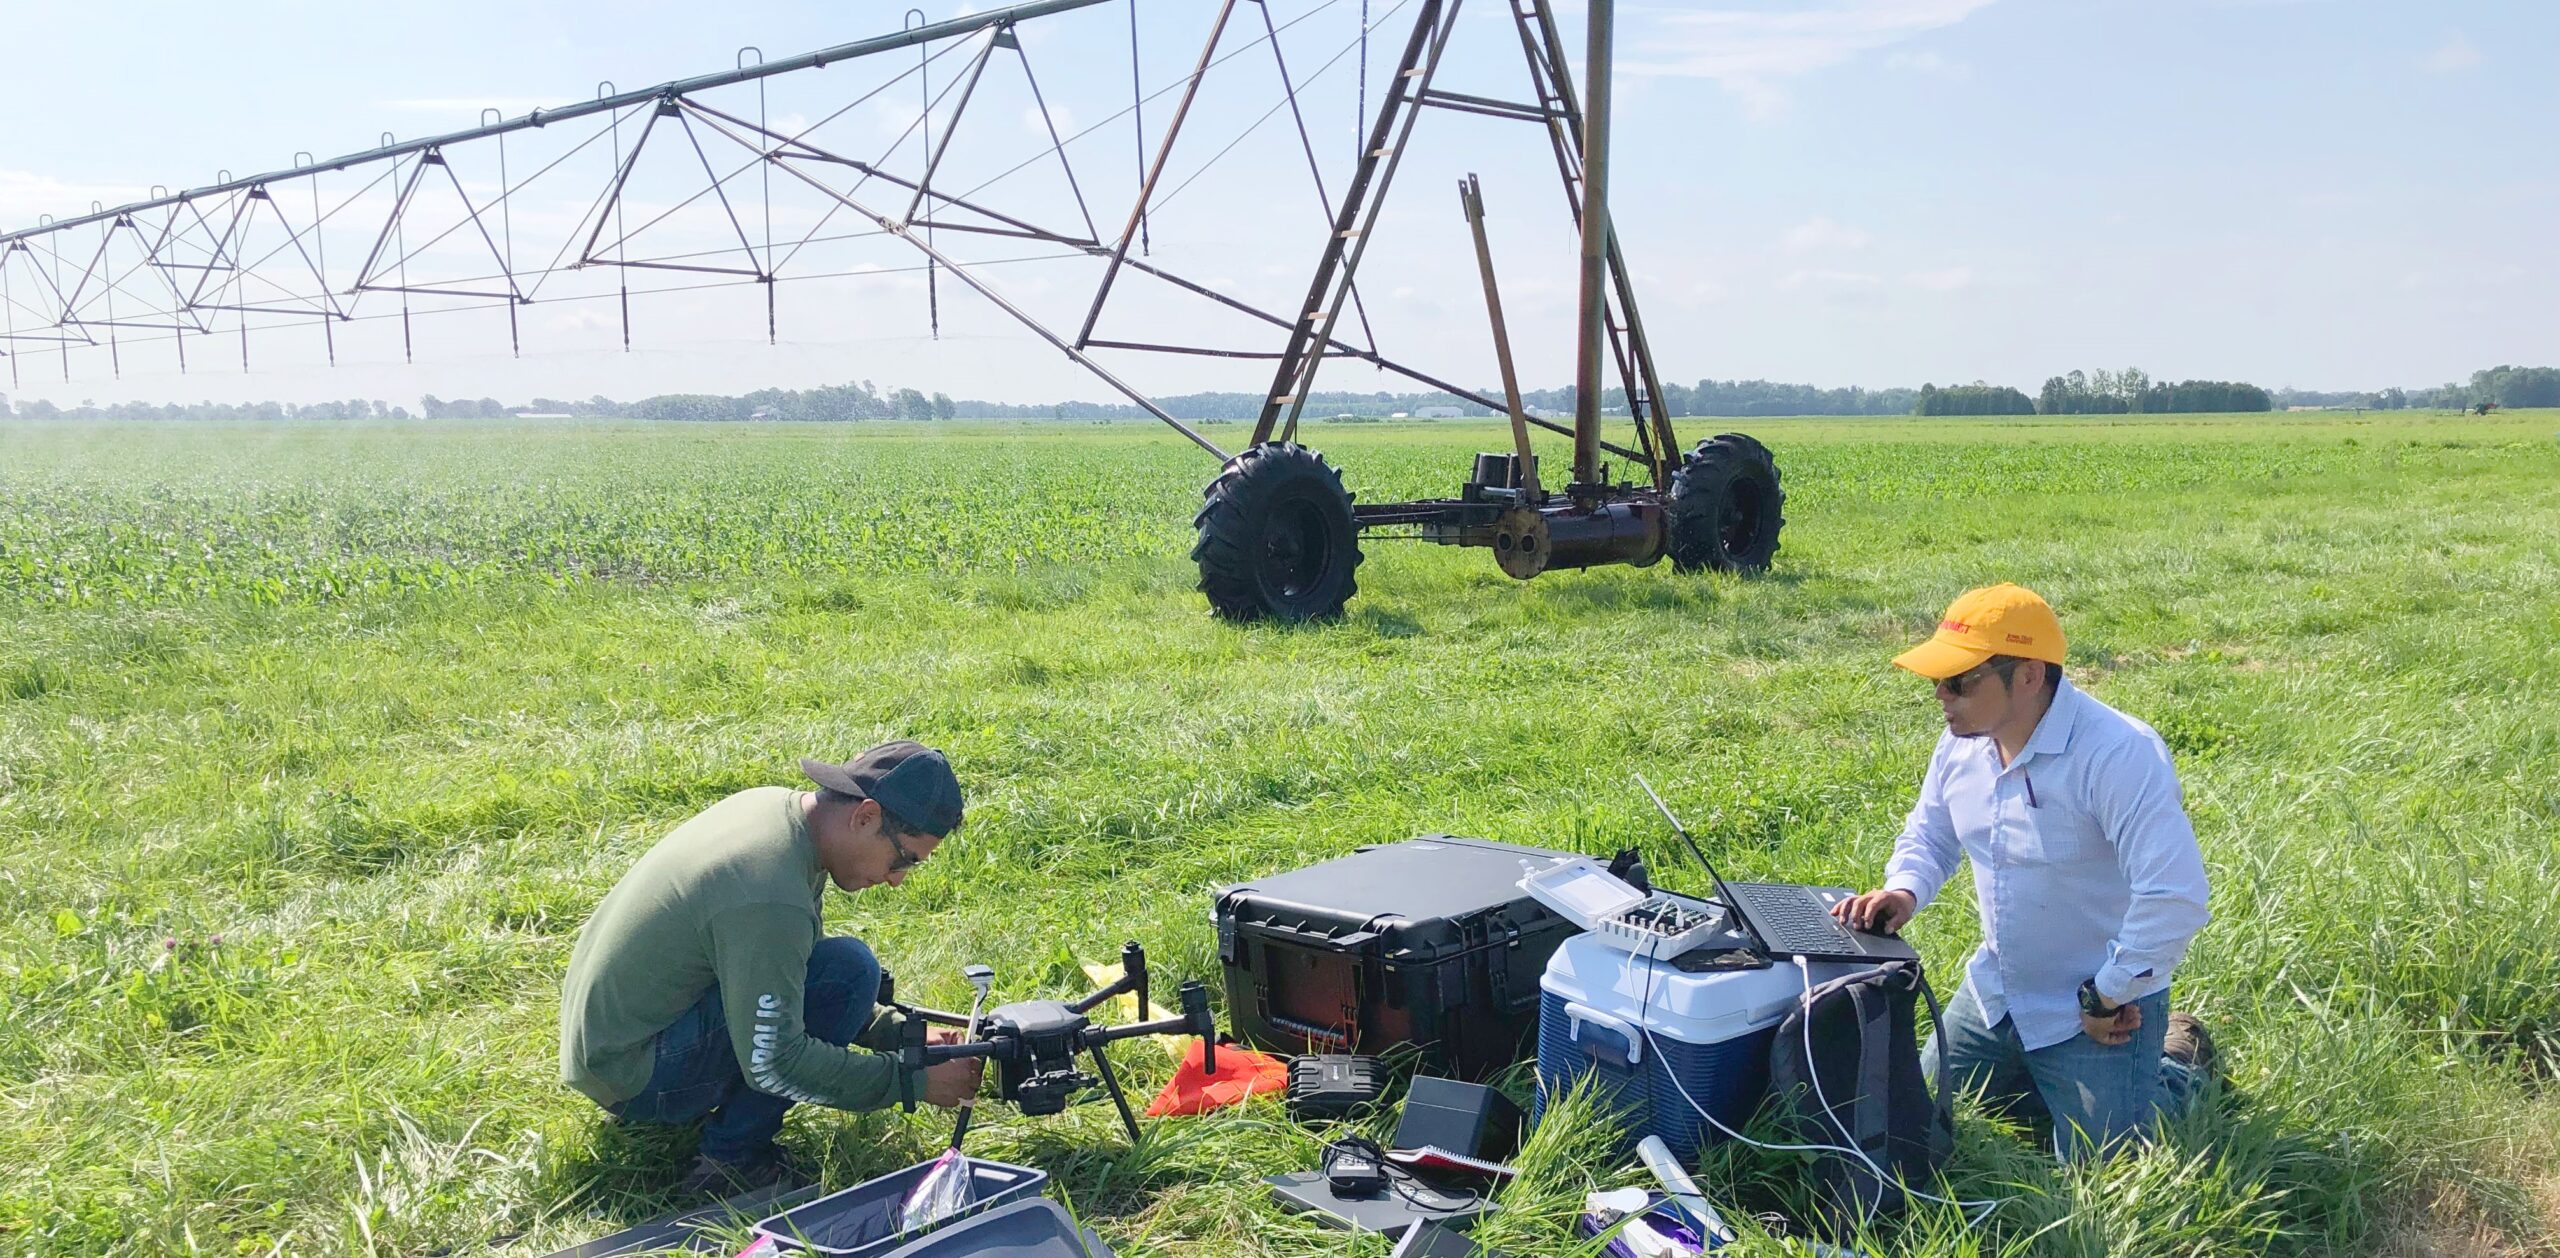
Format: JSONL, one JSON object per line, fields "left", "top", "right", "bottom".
{"left": 1533, "top": 902, "right": 1859, "bottom": 1161}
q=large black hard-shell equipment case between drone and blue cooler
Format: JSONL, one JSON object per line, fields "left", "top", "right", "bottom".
{"left": 1216, "top": 835, "right": 1580, "bottom": 1079}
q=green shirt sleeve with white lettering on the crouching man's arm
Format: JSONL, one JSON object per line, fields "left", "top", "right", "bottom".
{"left": 712, "top": 904, "right": 924, "bottom": 1109}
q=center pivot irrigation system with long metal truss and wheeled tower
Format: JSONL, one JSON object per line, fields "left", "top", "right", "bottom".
{"left": 0, "top": 0, "right": 1782, "bottom": 620}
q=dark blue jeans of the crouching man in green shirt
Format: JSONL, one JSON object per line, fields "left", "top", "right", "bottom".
{"left": 612, "top": 935, "right": 881, "bottom": 1163}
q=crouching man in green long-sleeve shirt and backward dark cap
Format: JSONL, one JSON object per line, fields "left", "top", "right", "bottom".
{"left": 561, "top": 743, "right": 980, "bottom": 1191}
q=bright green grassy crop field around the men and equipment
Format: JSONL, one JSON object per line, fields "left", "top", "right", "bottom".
{"left": 0, "top": 413, "right": 2560, "bottom": 1258}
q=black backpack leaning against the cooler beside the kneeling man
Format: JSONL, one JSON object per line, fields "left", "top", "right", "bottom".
{"left": 1769, "top": 961, "right": 1956, "bottom": 1225}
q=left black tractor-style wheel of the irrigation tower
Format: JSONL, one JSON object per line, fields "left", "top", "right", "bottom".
{"left": 1190, "top": 443, "right": 1359, "bottom": 620}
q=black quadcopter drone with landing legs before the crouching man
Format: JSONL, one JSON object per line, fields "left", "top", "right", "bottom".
{"left": 881, "top": 940, "right": 1219, "bottom": 1148}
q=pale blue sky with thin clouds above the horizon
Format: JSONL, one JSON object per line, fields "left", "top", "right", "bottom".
{"left": 0, "top": 0, "right": 2560, "bottom": 405}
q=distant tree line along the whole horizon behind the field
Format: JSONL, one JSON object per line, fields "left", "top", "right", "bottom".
{"left": 0, "top": 366, "right": 2560, "bottom": 420}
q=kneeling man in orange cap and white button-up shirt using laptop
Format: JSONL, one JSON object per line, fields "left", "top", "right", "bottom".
{"left": 1836, "top": 584, "right": 2212, "bottom": 1156}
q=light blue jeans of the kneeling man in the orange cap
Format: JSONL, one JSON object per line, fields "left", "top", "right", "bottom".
{"left": 1920, "top": 984, "right": 2194, "bottom": 1158}
